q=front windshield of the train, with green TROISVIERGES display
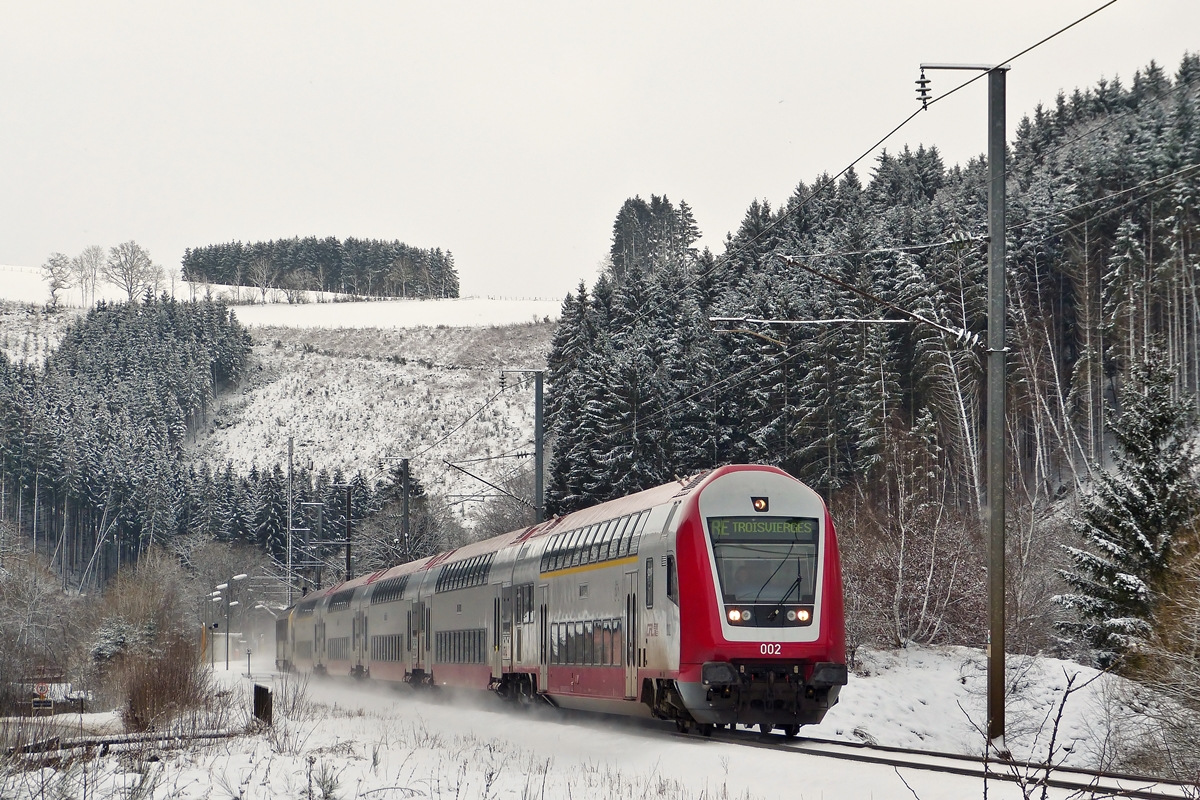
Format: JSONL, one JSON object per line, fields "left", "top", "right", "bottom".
{"left": 708, "top": 517, "right": 821, "bottom": 604}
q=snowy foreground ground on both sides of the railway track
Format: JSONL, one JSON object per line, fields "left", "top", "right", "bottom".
{"left": 0, "top": 648, "right": 1156, "bottom": 800}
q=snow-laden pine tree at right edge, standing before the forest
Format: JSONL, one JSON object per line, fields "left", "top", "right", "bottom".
{"left": 1058, "top": 354, "right": 1200, "bottom": 666}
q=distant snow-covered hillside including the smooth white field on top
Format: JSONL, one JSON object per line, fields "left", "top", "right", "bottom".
{"left": 0, "top": 266, "right": 560, "bottom": 523}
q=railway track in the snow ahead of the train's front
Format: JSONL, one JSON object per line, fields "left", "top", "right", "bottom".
{"left": 700, "top": 730, "right": 1200, "bottom": 800}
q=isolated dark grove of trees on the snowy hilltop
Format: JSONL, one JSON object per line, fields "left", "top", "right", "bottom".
{"left": 182, "top": 236, "right": 458, "bottom": 299}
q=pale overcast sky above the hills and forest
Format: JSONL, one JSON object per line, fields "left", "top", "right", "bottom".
{"left": 0, "top": 0, "right": 1200, "bottom": 297}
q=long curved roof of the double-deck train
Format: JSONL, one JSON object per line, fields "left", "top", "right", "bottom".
{"left": 319, "top": 464, "right": 786, "bottom": 595}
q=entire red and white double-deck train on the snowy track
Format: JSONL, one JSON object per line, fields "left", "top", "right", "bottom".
{"left": 276, "top": 465, "right": 846, "bottom": 735}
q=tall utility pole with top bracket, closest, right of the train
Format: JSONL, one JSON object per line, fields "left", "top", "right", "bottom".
{"left": 917, "top": 64, "right": 1008, "bottom": 756}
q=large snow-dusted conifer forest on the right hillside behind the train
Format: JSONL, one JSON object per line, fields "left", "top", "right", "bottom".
{"left": 547, "top": 55, "right": 1200, "bottom": 655}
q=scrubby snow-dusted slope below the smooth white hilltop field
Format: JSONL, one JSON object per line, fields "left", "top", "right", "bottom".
{"left": 190, "top": 321, "right": 553, "bottom": 522}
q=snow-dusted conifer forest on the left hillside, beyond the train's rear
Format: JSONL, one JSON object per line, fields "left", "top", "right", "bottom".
{"left": 0, "top": 294, "right": 437, "bottom": 590}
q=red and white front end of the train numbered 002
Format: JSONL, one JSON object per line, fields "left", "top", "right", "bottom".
{"left": 655, "top": 468, "right": 847, "bottom": 734}
